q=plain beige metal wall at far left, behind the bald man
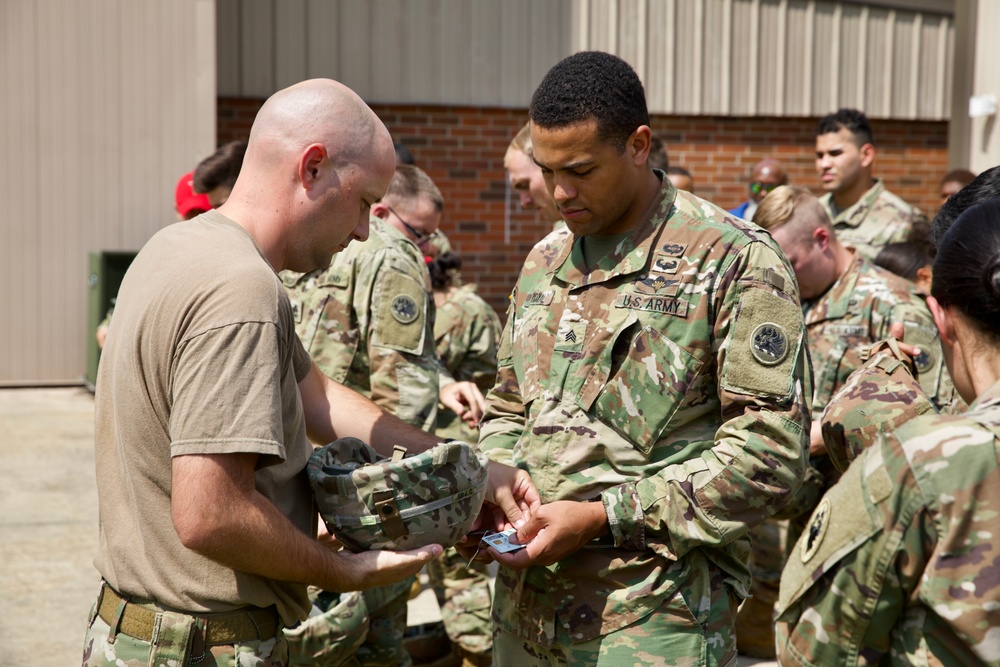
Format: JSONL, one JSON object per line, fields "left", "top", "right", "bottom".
{"left": 0, "top": 0, "right": 216, "bottom": 384}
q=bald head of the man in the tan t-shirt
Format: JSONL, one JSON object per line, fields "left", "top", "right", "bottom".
{"left": 225, "top": 79, "right": 396, "bottom": 272}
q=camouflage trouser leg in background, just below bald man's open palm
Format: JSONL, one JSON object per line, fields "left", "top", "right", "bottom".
{"left": 427, "top": 548, "right": 493, "bottom": 656}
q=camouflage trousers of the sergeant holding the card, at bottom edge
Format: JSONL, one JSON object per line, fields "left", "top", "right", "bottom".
{"left": 493, "top": 586, "right": 739, "bottom": 667}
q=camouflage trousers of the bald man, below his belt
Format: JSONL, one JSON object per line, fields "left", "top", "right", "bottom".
{"left": 81, "top": 604, "right": 288, "bottom": 667}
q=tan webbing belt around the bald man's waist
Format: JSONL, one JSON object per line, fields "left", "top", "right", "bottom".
{"left": 97, "top": 584, "right": 280, "bottom": 646}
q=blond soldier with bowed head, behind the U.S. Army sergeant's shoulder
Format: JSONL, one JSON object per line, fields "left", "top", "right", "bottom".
{"left": 752, "top": 186, "right": 944, "bottom": 655}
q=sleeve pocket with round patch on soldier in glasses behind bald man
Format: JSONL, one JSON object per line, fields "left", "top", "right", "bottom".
{"left": 371, "top": 271, "right": 428, "bottom": 354}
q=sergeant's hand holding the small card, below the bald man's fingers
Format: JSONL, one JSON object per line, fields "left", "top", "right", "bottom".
{"left": 490, "top": 500, "right": 608, "bottom": 570}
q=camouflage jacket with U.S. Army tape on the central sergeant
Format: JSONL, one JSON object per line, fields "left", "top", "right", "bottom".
{"left": 480, "top": 179, "right": 809, "bottom": 645}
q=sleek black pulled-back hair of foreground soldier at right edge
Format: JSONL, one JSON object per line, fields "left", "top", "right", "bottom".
{"left": 931, "top": 199, "right": 1000, "bottom": 341}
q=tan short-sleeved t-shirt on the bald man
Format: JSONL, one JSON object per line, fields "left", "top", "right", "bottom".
{"left": 94, "top": 211, "right": 315, "bottom": 624}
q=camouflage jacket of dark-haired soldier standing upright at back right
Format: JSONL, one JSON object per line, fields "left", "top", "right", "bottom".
{"left": 820, "top": 179, "right": 926, "bottom": 261}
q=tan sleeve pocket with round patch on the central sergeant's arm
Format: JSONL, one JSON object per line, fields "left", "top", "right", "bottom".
{"left": 721, "top": 287, "right": 802, "bottom": 396}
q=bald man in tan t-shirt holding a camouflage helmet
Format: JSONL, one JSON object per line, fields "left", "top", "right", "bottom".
{"left": 83, "top": 80, "right": 538, "bottom": 666}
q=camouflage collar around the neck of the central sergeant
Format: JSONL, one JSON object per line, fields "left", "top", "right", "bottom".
{"left": 551, "top": 174, "right": 677, "bottom": 287}
